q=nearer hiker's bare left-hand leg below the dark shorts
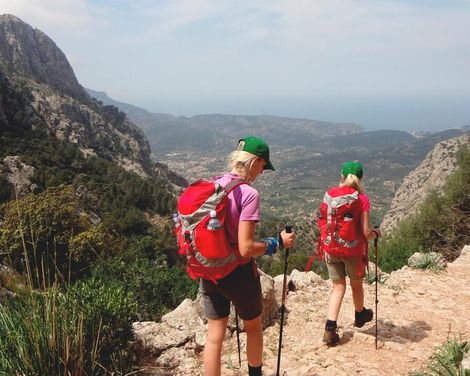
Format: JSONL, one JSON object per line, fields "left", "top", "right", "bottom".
{"left": 204, "top": 317, "right": 228, "bottom": 376}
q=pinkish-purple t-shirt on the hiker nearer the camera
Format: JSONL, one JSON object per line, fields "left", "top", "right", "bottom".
{"left": 215, "top": 172, "right": 260, "bottom": 244}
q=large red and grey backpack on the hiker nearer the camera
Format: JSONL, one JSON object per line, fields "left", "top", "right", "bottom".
{"left": 174, "top": 179, "right": 247, "bottom": 282}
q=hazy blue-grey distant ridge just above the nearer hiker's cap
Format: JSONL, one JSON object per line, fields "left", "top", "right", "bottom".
{"left": 87, "top": 89, "right": 362, "bottom": 153}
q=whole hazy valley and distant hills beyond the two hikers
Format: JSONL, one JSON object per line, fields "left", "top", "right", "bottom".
{"left": 87, "top": 89, "right": 465, "bottom": 223}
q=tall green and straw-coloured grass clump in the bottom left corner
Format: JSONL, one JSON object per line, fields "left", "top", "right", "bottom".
{"left": 0, "top": 290, "right": 85, "bottom": 375}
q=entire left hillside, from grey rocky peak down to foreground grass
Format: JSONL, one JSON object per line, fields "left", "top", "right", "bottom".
{"left": 0, "top": 15, "right": 195, "bottom": 376}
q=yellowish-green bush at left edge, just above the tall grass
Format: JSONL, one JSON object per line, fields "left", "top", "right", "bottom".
{"left": 0, "top": 186, "right": 113, "bottom": 288}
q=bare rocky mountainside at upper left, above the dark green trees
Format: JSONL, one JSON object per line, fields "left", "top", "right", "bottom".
{"left": 0, "top": 15, "right": 153, "bottom": 176}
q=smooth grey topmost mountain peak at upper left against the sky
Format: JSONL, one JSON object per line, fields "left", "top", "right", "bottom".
{"left": 0, "top": 14, "right": 87, "bottom": 98}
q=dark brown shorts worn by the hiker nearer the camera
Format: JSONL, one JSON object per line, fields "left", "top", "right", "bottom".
{"left": 199, "top": 261, "right": 263, "bottom": 320}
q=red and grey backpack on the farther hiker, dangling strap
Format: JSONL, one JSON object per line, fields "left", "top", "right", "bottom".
{"left": 306, "top": 187, "right": 367, "bottom": 271}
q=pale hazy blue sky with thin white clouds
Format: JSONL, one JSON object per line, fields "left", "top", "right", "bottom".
{"left": 0, "top": 0, "right": 470, "bottom": 101}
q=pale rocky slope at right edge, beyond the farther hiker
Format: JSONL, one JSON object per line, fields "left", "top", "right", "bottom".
{"left": 381, "top": 135, "right": 470, "bottom": 233}
